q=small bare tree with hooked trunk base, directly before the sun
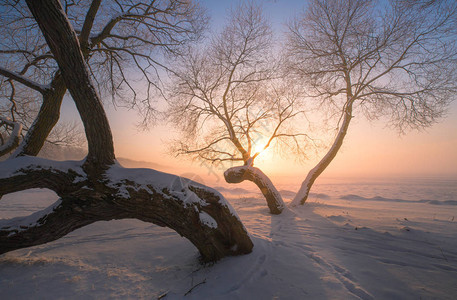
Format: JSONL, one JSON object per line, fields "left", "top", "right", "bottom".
{"left": 168, "top": 2, "right": 307, "bottom": 214}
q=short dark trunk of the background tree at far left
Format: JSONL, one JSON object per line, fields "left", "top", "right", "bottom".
{"left": 10, "top": 74, "right": 67, "bottom": 158}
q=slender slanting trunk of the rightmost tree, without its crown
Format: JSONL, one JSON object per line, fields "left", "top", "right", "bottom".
{"left": 290, "top": 103, "right": 352, "bottom": 206}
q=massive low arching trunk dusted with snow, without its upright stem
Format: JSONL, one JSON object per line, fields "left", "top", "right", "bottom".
{"left": 0, "top": 157, "right": 253, "bottom": 261}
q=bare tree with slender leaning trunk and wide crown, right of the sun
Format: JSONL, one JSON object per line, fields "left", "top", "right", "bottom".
{"left": 288, "top": 0, "right": 457, "bottom": 204}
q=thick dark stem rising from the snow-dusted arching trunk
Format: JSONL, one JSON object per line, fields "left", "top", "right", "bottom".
{"left": 26, "top": 0, "right": 114, "bottom": 171}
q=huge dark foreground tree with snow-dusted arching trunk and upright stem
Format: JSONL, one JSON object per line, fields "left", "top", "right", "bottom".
{"left": 0, "top": 0, "right": 253, "bottom": 260}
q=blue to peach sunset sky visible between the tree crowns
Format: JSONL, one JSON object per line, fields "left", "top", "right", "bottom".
{"left": 63, "top": 0, "right": 457, "bottom": 184}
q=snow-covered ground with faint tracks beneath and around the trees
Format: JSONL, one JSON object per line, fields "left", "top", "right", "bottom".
{"left": 0, "top": 179, "right": 457, "bottom": 299}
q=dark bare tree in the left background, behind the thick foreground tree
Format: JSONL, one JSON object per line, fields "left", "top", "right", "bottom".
{"left": 0, "top": 0, "right": 206, "bottom": 156}
